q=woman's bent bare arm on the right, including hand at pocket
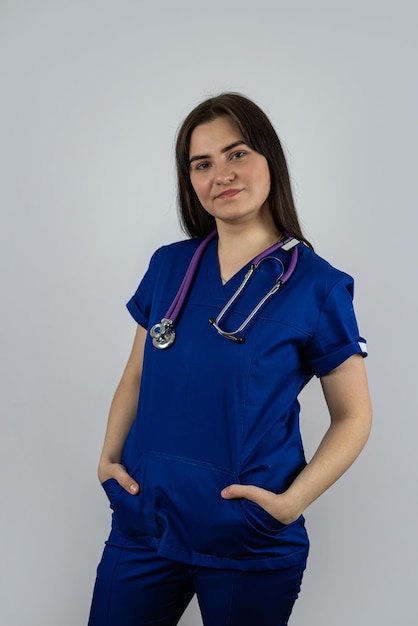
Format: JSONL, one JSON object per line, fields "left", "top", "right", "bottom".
{"left": 221, "top": 354, "right": 372, "bottom": 524}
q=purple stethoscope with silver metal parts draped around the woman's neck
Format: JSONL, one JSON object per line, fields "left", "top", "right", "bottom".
{"left": 150, "top": 230, "right": 299, "bottom": 350}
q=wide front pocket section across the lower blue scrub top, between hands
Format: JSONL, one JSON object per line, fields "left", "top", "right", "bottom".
{"left": 108, "top": 452, "right": 307, "bottom": 568}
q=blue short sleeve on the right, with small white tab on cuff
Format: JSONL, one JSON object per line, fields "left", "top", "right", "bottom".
{"left": 306, "top": 275, "right": 367, "bottom": 377}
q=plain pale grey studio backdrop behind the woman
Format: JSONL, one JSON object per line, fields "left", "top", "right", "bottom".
{"left": 0, "top": 0, "right": 418, "bottom": 626}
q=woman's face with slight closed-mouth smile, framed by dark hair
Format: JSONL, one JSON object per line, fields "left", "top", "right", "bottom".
{"left": 189, "top": 117, "right": 271, "bottom": 224}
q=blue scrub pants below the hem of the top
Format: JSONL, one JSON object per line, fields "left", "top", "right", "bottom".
{"left": 88, "top": 532, "right": 304, "bottom": 626}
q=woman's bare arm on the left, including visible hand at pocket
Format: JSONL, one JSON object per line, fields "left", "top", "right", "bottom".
{"left": 98, "top": 326, "right": 147, "bottom": 495}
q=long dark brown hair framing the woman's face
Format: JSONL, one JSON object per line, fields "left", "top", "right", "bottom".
{"left": 176, "top": 93, "right": 312, "bottom": 248}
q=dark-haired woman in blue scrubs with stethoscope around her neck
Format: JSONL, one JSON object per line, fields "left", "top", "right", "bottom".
{"left": 89, "top": 93, "right": 371, "bottom": 626}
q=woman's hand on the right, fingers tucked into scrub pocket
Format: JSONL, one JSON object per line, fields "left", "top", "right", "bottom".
{"left": 221, "top": 485, "right": 302, "bottom": 524}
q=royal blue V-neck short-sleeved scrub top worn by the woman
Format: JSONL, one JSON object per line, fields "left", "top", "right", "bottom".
{"left": 104, "top": 238, "right": 366, "bottom": 570}
